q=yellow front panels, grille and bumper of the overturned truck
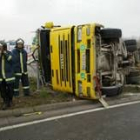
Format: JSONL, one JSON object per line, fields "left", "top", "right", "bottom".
{"left": 50, "top": 24, "right": 102, "bottom": 99}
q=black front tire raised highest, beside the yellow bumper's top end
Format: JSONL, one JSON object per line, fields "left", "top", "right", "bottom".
{"left": 101, "top": 28, "right": 122, "bottom": 39}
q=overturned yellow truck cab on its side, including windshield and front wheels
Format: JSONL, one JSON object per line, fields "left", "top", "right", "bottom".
{"left": 38, "top": 23, "right": 127, "bottom": 99}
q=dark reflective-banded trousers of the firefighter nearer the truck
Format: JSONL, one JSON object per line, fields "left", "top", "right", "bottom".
{"left": 14, "top": 74, "right": 30, "bottom": 96}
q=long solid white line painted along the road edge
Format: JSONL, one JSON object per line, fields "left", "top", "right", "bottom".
{"left": 0, "top": 101, "right": 140, "bottom": 132}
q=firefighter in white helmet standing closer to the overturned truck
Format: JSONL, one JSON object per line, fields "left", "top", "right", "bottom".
{"left": 12, "top": 39, "right": 30, "bottom": 96}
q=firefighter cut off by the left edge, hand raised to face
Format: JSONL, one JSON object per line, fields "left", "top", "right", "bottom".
{"left": 0, "top": 42, "right": 15, "bottom": 110}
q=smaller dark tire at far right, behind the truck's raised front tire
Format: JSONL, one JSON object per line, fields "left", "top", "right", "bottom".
{"left": 124, "top": 39, "right": 137, "bottom": 52}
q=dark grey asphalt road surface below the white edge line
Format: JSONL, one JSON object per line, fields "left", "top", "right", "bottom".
{"left": 0, "top": 104, "right": 140, "bottom": 140}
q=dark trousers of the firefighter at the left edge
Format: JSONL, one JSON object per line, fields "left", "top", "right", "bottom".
{"left": 0, "top": 80, "right": 14, "bottom": 105}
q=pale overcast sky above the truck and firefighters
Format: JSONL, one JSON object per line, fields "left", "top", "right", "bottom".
{"left": 0, "top": 0, "right": 140, "bottom": 43}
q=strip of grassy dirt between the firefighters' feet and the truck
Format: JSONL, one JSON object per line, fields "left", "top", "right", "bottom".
{"left": 0, "top": 87, "right": 74, "bottom": 109}
